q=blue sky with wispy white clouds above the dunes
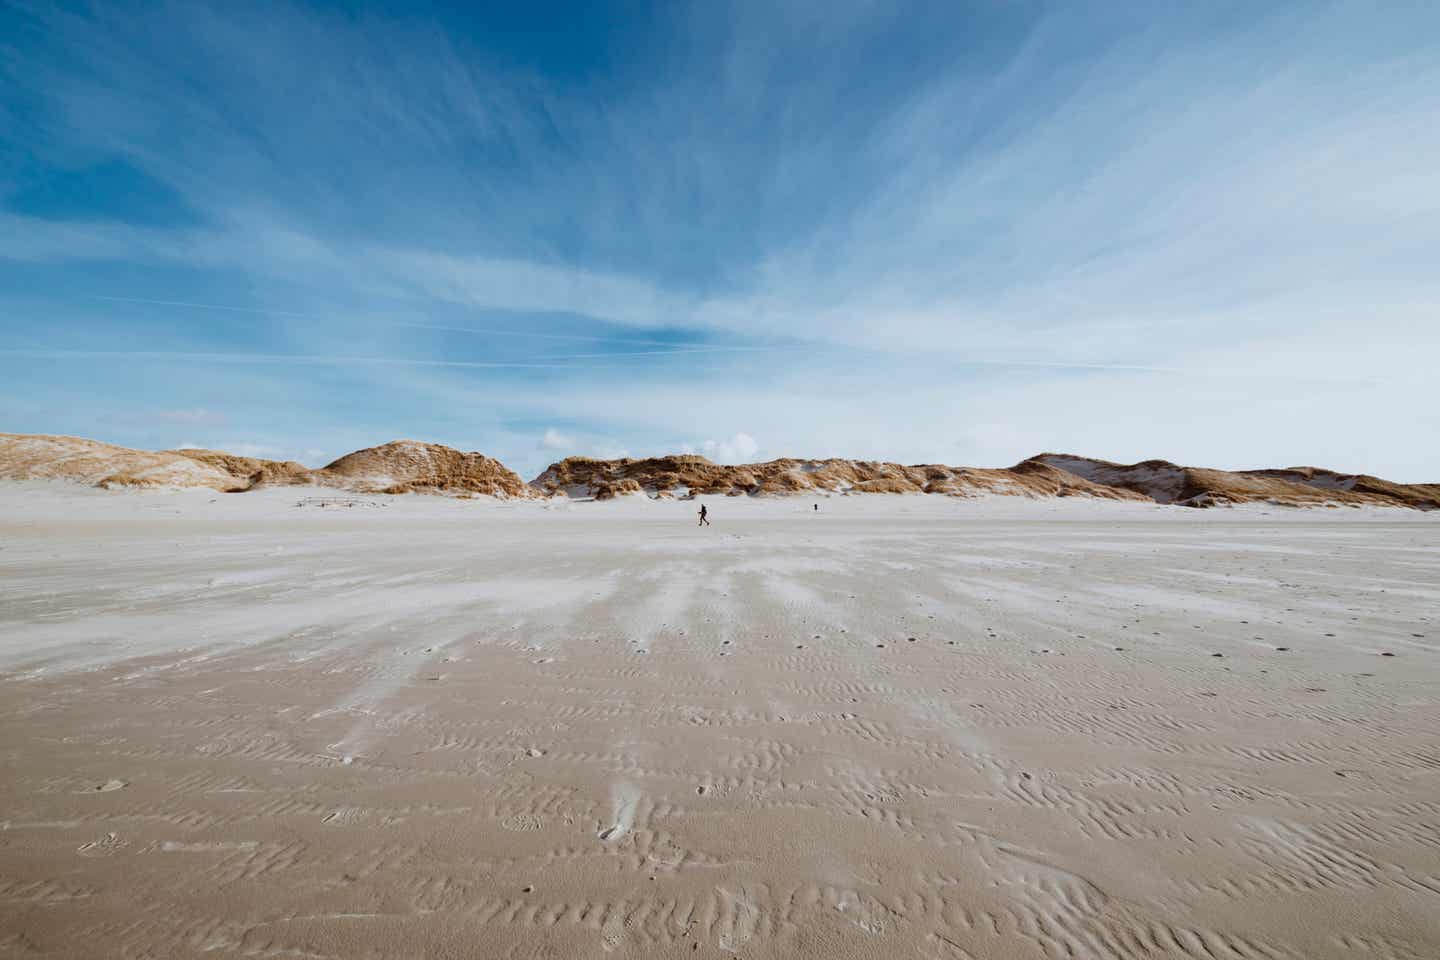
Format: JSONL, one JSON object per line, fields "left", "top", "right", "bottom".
{"left": 0, "top": 0, "right": 1440, "bottom": 482}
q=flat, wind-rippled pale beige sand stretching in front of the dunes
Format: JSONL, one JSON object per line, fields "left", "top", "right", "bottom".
{"left": 0, "top": 484, "right": 1440, "bottom": 960}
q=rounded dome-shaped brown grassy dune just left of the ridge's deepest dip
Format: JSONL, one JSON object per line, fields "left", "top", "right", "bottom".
{"left": 315, "top": 440, "right": 534, "bottom": 497}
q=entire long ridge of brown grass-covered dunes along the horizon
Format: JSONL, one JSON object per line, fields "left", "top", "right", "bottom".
{"left": 0, "top": 433, "right": 1440, "bottom": 511}
